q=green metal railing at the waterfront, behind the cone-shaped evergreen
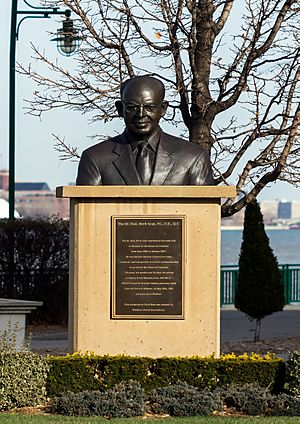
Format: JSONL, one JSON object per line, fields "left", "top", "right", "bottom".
{"left": 221, "top": 264, "right": 300, "bottom": 306}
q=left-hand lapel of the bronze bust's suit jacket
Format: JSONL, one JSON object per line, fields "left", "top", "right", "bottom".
{"left": 113, "top": 134, "right": 140, "bottom": 185}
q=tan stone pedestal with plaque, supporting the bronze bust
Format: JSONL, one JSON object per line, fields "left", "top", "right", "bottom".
{"left": 57, "top": 186, "right": 235, "bottom": 357}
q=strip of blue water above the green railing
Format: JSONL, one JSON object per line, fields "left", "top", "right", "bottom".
{"left": 221, "top": 230, "right": 300, "bottom": 265}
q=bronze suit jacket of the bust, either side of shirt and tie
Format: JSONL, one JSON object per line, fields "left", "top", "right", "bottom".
{"left": 76, "top": 132, "right": 214, "bottom": 185}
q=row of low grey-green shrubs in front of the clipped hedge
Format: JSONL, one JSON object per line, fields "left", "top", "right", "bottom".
{"left": 50, "top": 381, "right": 300, "bottom": 418}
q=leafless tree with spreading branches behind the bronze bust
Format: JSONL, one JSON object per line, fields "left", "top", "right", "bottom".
{"left": 21, "top": 0, "right": 300, "bottom": 216}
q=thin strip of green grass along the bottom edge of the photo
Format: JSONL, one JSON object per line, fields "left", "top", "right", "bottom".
{"left": 0, "top": 414, "right": 299, "bottom": 424}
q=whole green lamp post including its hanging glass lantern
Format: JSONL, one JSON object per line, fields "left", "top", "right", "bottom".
{"left": 8, "top": 0, "right": 81, "bottom": 220}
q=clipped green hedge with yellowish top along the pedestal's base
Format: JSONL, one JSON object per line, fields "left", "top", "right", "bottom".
{"left": 47, "top": 354, "right": 285, "bottom": 396}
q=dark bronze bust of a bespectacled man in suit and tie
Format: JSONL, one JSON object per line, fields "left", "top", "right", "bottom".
{"left": 76, "top": 76, "right": 214, "bottom": 185}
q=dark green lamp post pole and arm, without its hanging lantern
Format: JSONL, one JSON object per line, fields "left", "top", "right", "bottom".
{"left": 8, "top": 0, "right": 71, "bottom": 220}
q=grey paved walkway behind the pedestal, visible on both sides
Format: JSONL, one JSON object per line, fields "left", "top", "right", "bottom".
{"left": 31, "top": 305, "right": 300, "bottom": 353}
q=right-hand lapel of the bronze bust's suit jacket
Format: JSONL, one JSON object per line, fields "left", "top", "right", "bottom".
{"left": 151, "top": 132, "right": 175, "bottom": 185}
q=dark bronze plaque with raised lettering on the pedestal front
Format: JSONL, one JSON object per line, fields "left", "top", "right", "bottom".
{"left": 112, "top": 216, "right": 185, "bottom": 319}
